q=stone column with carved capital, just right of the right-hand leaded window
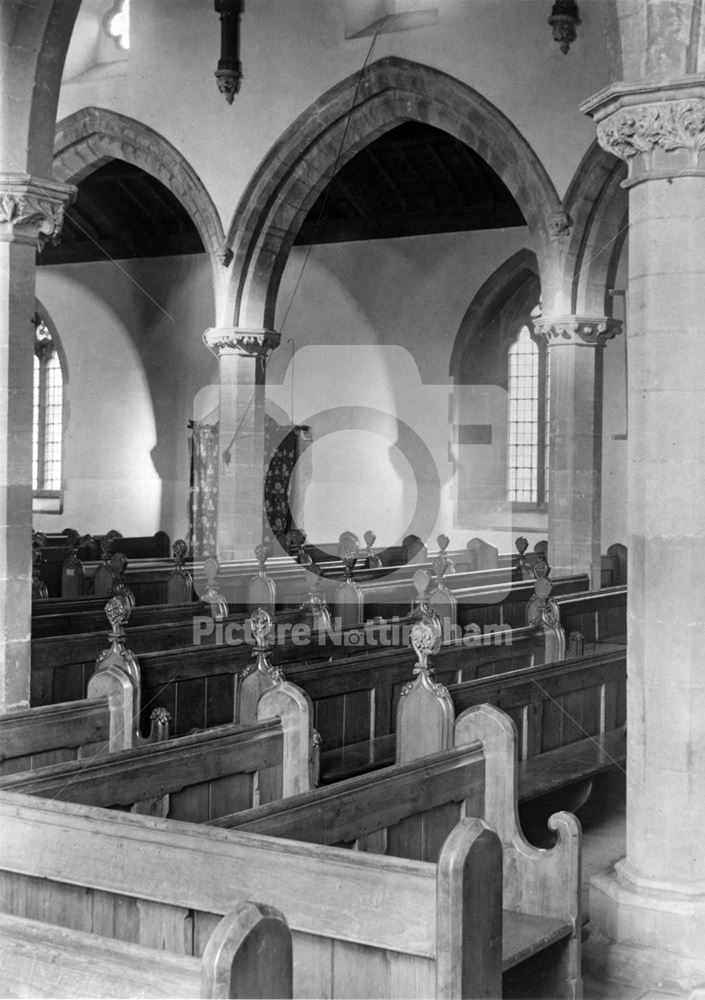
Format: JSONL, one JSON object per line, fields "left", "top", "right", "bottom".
{"left": 534, "top": 316, "right": 620, "bottom": 588}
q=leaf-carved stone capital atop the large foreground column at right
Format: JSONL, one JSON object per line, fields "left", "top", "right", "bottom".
{"left": 581, "top": 80, "right": 705, "bottom": 188}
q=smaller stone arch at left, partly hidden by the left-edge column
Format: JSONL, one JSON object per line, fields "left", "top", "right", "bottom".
{"left": 54, "top": 107, "right": 223, "bottom": 270}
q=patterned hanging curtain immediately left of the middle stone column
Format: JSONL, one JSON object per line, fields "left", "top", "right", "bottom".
{"left": 189, "top": 424, "right": 218, "bottom": 559}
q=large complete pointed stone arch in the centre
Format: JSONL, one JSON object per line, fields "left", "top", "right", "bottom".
{"left": 223, "top": 56, "right": 560, "bottom": 328}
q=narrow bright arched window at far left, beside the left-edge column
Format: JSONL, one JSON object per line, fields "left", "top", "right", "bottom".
{"left": 32, "top": 313, "right": 66, "bottom": 512}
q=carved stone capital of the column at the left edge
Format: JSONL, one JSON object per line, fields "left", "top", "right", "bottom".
{"left": 0, "top": 173, "right": 76, "bottom": 250}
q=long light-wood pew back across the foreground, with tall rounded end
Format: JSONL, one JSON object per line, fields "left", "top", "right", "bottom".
{"left": 0, "top": 791, "right": 501, "bottom": 998}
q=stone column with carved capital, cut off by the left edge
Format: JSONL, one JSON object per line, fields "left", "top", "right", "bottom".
{"left": 0, "top": 173, "right": 76, "bottom": 712}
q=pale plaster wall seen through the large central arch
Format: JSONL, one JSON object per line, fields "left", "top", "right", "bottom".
{"left": 267, "top": 228, "right": 546, "bottom": 550}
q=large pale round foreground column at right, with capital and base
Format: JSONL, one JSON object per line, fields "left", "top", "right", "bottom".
{"left": 583, "top": 80, "right": 705, "bottom": 989}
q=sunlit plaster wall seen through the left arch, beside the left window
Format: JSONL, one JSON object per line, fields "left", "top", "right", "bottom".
{"left": 34, "top": 255, "right": 217, "bottom": 539}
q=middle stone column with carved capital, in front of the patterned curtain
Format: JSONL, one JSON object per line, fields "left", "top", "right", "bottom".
{"left": 203, "top": 327, "right": 280, "bottom": 562}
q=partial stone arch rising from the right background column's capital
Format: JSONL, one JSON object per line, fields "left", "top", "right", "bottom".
{"left": 564, "top": 141, "right": 629, "bottom": 316}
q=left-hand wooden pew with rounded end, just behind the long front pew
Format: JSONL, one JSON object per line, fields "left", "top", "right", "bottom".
{"left": 0, "top": 682, "right": 312, "bottom": 823}
